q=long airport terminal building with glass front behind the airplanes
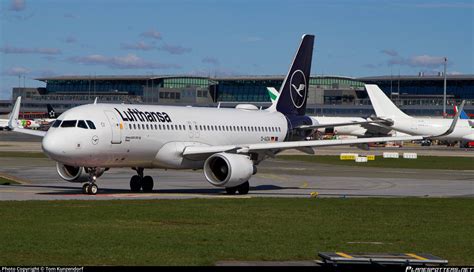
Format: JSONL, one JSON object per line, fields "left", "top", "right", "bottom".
{"left": 0, "top": 74, "right": 474, "bottom": 116}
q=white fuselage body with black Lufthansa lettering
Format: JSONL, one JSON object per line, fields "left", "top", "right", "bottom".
{"left": 42, "top": 104, "right": 287, "bottom": 169}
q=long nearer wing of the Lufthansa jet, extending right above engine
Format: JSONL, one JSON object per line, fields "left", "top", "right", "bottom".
{"left": 182, "top": 136, "right": 424, "bottom": 157}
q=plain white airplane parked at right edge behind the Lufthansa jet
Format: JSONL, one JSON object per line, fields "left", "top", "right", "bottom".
{"left": 365, "top": 84, "right": 474, "bottom": 141}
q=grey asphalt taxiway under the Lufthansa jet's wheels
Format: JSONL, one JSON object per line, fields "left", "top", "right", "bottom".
{"left": 0, "top": 154, "right": 474, "bottom": 200}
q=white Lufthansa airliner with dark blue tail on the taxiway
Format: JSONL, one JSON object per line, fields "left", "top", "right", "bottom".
{"left": 11, "top": 35, "right": 430, "bottom": 194}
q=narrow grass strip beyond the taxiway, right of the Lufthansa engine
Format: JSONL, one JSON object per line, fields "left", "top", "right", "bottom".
{"left": 277, "top": 155, "right": 474, "bottom": 170}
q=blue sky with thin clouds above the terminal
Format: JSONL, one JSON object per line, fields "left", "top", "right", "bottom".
{"left": 0, "top": 0, "right": 474, "bottom": 99}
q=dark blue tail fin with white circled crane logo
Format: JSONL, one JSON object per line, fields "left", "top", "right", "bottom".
{"left": 268, "top": 35, "right": 314, "bottom": 116}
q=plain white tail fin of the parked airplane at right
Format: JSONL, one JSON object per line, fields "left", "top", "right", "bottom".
{"left": 365, "top": 84, "right": 411, "bottom": 118}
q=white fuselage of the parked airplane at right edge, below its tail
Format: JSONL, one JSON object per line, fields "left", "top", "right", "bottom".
{"left": 390, "top": 117, "right": 474, "bottom": 141}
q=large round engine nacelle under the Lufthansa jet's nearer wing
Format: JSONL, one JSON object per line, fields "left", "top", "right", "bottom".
{"left": 204, "top": 153, "right": 256, "bottom": 187}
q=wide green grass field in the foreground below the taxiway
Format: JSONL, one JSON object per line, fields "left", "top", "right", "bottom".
{"left": 0, "top": 198, "right": 474, "bottom": 265}
